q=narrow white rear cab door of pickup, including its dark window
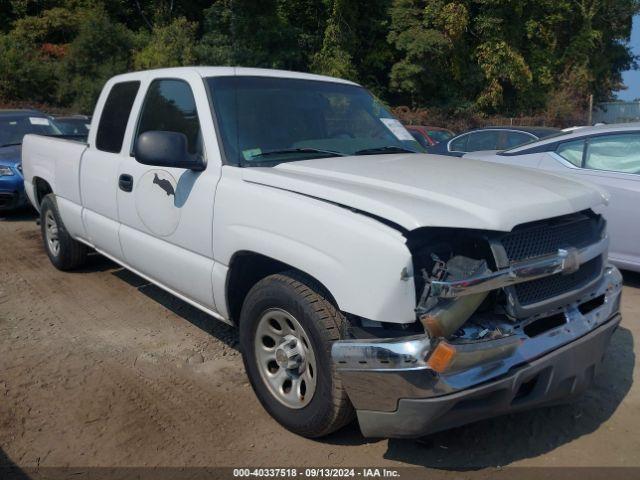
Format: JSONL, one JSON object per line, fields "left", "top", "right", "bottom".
{"left": 80, "top": 80, "right": 140, "bottom": 259}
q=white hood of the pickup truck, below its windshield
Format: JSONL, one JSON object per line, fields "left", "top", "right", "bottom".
{"left": 243, "top": 154, "right": 606, "bottom": 231}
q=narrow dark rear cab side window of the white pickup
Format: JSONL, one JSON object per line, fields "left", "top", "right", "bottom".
{"left": 96, "top": 82, "right": 140, "bottom": 153}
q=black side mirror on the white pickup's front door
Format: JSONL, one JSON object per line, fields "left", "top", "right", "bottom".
{"left": 133, "top": 130, "right": 205, "bottom": 170}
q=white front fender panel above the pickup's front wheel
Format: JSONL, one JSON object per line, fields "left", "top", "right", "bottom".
{"left": 213, "top": 168, "right": 416, "bottom": 323}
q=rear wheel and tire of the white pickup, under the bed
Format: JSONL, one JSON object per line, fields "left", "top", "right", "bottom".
{"left": 40, "top": 193, "right": 87, "bottom": 270}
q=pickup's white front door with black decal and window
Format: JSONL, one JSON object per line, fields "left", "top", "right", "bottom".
{"left": 117, "top": 71, "right": 221, "bottom": 312}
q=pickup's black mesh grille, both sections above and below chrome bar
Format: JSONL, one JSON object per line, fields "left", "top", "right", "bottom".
{"left": 501, "top": 212, "right": 604, "bottom": 307}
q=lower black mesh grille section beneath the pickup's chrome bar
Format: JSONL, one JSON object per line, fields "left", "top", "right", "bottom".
{"left": 515, "top": 257, "right": 602, "bottom": 305}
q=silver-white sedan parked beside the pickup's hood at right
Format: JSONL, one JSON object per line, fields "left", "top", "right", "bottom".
{"left": 464, "top": 123, "right": 640, "bottom": 271}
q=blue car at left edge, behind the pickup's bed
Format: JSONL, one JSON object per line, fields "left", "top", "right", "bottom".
{"left": 0, "top": 110, "right": 60, "bottom": 210}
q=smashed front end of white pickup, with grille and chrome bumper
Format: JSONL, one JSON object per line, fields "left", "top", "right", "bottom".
{"left": 332, "top": 211, "right": 622, "bottom": 436}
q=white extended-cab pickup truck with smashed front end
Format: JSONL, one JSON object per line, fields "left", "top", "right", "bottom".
{"left": 23, "top": 67, "right": 621, "bottom": 437}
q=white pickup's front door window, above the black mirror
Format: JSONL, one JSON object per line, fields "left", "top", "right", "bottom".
{"left": 136, "top": 79, "right": 202, "bottom": 155}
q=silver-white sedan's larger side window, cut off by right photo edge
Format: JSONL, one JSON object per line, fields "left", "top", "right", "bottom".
{"left": 584, "top": 133, "right": 640, "bottom": 173}
